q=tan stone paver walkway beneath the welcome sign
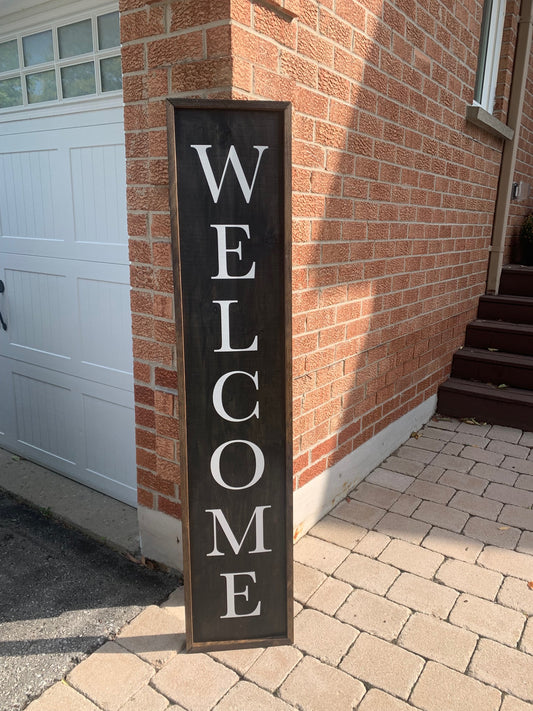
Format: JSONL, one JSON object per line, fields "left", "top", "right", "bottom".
{"left": 28, "top": 419, "right": 533, "bottom": 711}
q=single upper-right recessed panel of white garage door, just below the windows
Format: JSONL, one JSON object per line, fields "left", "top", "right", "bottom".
{"left": 70, "top": 144, "right": 127, "bottom": 244}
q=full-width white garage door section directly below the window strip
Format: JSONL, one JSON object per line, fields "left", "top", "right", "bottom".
{"left": 0, "top": 117, "right": 128, "bottom": 250}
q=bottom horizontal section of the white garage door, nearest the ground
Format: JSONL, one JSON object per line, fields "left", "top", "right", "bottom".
{"left": 0, "top": 357, "right": 137, "bottom": 506}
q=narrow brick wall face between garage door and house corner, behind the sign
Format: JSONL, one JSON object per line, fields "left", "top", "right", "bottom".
{"left": 120, "top": 0, "right": 235, "bottom": 517}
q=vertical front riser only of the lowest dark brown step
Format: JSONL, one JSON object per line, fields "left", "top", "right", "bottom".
{"left": 437, "top": 384, "right": 533, "bottom": 429}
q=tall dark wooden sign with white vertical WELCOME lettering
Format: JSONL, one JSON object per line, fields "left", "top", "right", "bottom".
{"left": 168, "top": 100, "right": 293, "bottom": 650}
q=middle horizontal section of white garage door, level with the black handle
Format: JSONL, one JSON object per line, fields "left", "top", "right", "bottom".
{"left": 0, "top": 250, "right": 133, "bottom": 391}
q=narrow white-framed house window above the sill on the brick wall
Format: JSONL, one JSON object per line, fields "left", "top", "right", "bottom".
{"left": 474, "top": 0, "right": 506, "bottom": 113}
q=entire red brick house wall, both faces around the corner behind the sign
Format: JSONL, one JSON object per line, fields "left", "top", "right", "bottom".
{"left": 121, "top": 0, "right": 516, "bottom": 515}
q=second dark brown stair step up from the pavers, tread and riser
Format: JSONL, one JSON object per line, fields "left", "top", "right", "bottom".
{"left": 452, "top": 346, "right": 533, "bottom": 390}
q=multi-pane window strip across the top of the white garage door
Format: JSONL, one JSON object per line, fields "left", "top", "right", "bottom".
{"left": 0, "top": 12, "right": 122, "bottom": 111}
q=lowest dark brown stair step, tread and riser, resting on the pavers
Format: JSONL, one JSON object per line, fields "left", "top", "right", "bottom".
{"left": 437, "top": 378, "right": 533, "bottom": 430}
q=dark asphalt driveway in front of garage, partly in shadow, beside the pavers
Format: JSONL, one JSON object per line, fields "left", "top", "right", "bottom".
{"left": 0, "top": 491, "right": 179, "bottom": 711}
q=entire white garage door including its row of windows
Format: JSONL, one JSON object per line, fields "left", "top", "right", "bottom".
{"left": 0, "top": 5, "right": 136, "bottom": 505}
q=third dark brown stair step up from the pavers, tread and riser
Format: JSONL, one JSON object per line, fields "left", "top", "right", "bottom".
{"left": 465, "top": 319, "right": 533, "bottom": 355}
